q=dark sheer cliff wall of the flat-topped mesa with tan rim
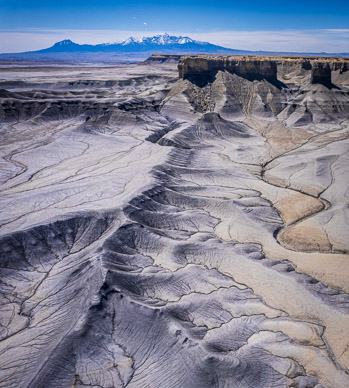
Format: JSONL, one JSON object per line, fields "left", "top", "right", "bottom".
{"left": 178, "top": 56, "right": 349, "bottom": 85}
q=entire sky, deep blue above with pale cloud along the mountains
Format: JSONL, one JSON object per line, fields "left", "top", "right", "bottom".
{"left": 0, "top": 0, "right": 349, "bottom": 52}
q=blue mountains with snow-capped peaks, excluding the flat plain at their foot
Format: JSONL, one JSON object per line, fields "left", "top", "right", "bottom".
{"left": 37, "top": 33, "right": 237, "bottom": 54}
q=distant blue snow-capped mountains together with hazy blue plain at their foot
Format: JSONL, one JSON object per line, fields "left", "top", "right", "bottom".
{"left": 0, "top": 33, "right": 349, "bottom": 62}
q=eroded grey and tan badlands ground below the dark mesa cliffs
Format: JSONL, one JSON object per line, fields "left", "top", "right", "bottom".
{"left": 0, "top": 65, "right": 349, "bottom": 388}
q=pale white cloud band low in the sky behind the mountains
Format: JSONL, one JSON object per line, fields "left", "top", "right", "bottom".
{"left": 0, "top": 28, "right": 349, "bottom": 53}
